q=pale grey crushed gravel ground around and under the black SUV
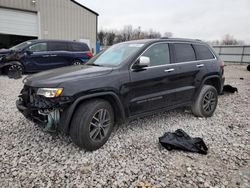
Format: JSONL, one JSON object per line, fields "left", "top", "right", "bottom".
{"left": 0, "top": 65, "right": 250, "bottom": 188}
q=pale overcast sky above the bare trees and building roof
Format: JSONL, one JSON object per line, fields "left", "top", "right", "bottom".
{"left": 78, "top": 0, "right": 250, "bottom": 44}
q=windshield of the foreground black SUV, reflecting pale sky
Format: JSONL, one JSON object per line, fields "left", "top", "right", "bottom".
{"left": 88, "top": 43, "right": 144, "bottom": 67}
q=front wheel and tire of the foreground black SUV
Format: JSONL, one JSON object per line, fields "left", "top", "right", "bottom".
{"left": 70, "top": 99, "right": 114, "bottom": 151}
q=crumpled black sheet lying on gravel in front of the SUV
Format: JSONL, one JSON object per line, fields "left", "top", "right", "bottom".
{"left": 159, "top": 129, "right": 208, "bottom": 154}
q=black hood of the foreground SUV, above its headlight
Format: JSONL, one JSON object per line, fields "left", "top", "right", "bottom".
{"left": 23, "top": 65, "right": 113, "bottom": 87}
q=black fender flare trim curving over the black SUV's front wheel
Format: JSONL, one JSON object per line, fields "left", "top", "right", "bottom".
{"left": 59, "top": 92, "right": 125, "bottom": 134}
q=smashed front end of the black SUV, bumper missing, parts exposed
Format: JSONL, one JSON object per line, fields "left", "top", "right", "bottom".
{"left": 16, "top": 85, "right": 73, "bottom": 131}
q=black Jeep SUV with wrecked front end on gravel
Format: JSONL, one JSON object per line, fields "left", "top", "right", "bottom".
{"left": 16, "top": 39, "right": 224, "bottom": 150}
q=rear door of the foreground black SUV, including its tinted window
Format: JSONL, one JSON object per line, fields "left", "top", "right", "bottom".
{"left": 171, "top": 42, "right": 199, "bottom": 105}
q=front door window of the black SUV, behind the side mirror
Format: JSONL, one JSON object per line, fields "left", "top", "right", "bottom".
{"left": 142, "top": 43, "right": 170, "bottom": 66}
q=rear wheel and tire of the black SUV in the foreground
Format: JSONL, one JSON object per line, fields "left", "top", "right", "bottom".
{"left": 191, "top": 85, "right": 218, "bottom": 117}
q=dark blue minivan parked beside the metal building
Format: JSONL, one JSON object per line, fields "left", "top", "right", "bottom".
{"left": 0, "top": 40, "right": 93, "bottom": 74}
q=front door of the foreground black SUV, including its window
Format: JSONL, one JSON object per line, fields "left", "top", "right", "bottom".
{"left": 126, "top": 43, "right": 179, "bottom": 116}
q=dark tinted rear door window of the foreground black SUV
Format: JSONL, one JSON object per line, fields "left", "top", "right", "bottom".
{"left": 174, "top": 43, "right": 195, "bottom": 63}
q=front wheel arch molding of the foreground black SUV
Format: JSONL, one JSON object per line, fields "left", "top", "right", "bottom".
{"left": 59, "top": 92, "right": 125, "bottom": 134}
